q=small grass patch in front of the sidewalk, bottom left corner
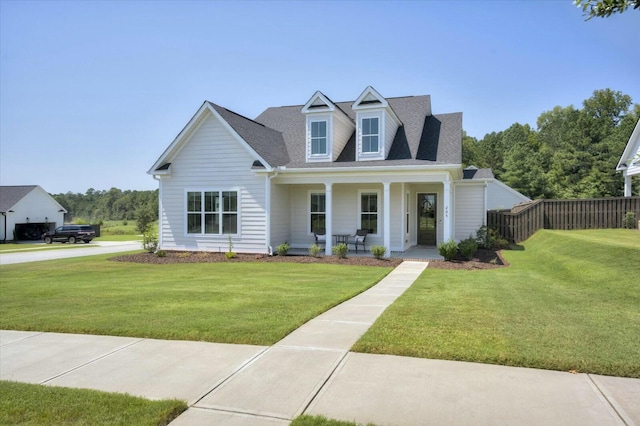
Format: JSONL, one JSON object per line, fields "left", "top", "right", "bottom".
{"left": 0, "top": 381, "right": 187, "bottom": 425}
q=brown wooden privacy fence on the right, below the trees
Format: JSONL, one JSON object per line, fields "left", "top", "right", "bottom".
{"left": 487, "top": 197, "right": 640, "bottom": 243}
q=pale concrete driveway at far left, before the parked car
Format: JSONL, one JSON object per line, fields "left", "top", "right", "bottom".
{"left": 0, "top": 241, "right": 142, "bottom": 265}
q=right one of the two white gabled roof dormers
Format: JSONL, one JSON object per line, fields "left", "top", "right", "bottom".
{"left": 351, "top": 86, "right": 402, "bottom": 161}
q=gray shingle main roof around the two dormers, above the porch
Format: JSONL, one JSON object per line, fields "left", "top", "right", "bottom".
{"left": 254, "top": 96, "right": 462, "bottom": 168}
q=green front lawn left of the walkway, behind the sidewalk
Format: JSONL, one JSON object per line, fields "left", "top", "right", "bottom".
{"left": 0, "top": 255, "right": 391, "bottom": 345}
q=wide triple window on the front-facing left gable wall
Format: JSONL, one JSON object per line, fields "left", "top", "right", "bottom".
{"left": 187, "top": 191, "right": 238, "bottom": 235}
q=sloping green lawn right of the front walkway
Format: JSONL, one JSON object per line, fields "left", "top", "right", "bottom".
{"left": 353, "top": 230, "right": 640, "bottom": 377}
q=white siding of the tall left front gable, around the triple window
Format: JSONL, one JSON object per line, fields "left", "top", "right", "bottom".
{"left": 161, "top": 113, "right": 267, "bottom": 253}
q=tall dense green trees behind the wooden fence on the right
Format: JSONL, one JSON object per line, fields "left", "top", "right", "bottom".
{"left": 462, "top": 89, "right": 640, "bottom": 199}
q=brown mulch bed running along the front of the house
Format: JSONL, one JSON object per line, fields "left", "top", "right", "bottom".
{"left": 109, "top": 246, "right": 506, "bottom": 269}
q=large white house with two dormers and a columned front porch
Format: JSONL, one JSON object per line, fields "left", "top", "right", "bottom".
{"left": 148, "top": 87, "right": 528, "bottom": 256}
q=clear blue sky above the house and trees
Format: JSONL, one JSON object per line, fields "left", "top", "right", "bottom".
{"left": 0, "top": 0, "right": 640, "bottom": 193}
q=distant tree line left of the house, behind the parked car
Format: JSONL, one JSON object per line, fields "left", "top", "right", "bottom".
{"left": 51, "top": 188, "right": 158, "bottom": 223}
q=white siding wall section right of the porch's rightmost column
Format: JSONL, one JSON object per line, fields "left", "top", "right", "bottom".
{"left": 453, "top": 184, "right": 487, "bottom": 241}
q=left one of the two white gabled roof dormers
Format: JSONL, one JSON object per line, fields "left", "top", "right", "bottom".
{"left": 301, "top": 91, "right": 355, "bottom": 163}
